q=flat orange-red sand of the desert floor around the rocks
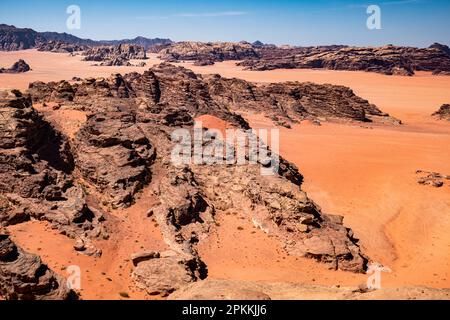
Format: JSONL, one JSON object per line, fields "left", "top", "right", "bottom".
{"left": 0, "top": 50, "right": 450, "bottom": 298}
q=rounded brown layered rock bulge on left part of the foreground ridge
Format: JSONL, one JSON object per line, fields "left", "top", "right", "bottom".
{"left": 74, "top": 111, "right": 155, "bottom": 207}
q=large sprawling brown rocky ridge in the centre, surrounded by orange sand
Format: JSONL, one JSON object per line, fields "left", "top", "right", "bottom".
{"left": 29, "top": 64, "right": 374, "bottom": 278}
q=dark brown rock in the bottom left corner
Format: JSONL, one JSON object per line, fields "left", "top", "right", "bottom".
{"left": 0, "top": 232, "right": 77, "bottom": 300}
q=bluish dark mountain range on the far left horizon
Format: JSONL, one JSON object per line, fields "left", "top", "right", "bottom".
{"left": 0, "top": 24, "right": 172, "bottom": 51}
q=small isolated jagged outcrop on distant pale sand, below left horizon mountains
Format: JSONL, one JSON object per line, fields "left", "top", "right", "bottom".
{"left": 83, "top": 44, "right": 147, "bottom": 66}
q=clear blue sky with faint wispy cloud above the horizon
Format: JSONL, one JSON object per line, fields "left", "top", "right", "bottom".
{"left": 0, "top": 0, "right": 450, "bottom": 47}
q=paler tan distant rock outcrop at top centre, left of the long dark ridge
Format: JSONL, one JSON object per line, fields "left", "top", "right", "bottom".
{"left": 159, "top": 42, "right": 258, "bottom": 65}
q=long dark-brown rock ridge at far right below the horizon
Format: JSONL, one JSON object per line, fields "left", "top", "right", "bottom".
{"left": 240, "top": 46, "right": 450, "bottom": 75}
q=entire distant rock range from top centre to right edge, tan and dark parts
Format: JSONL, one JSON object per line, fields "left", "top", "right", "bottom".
{"left": 159, "top": 42, "right": 450, "bottom": 76}
